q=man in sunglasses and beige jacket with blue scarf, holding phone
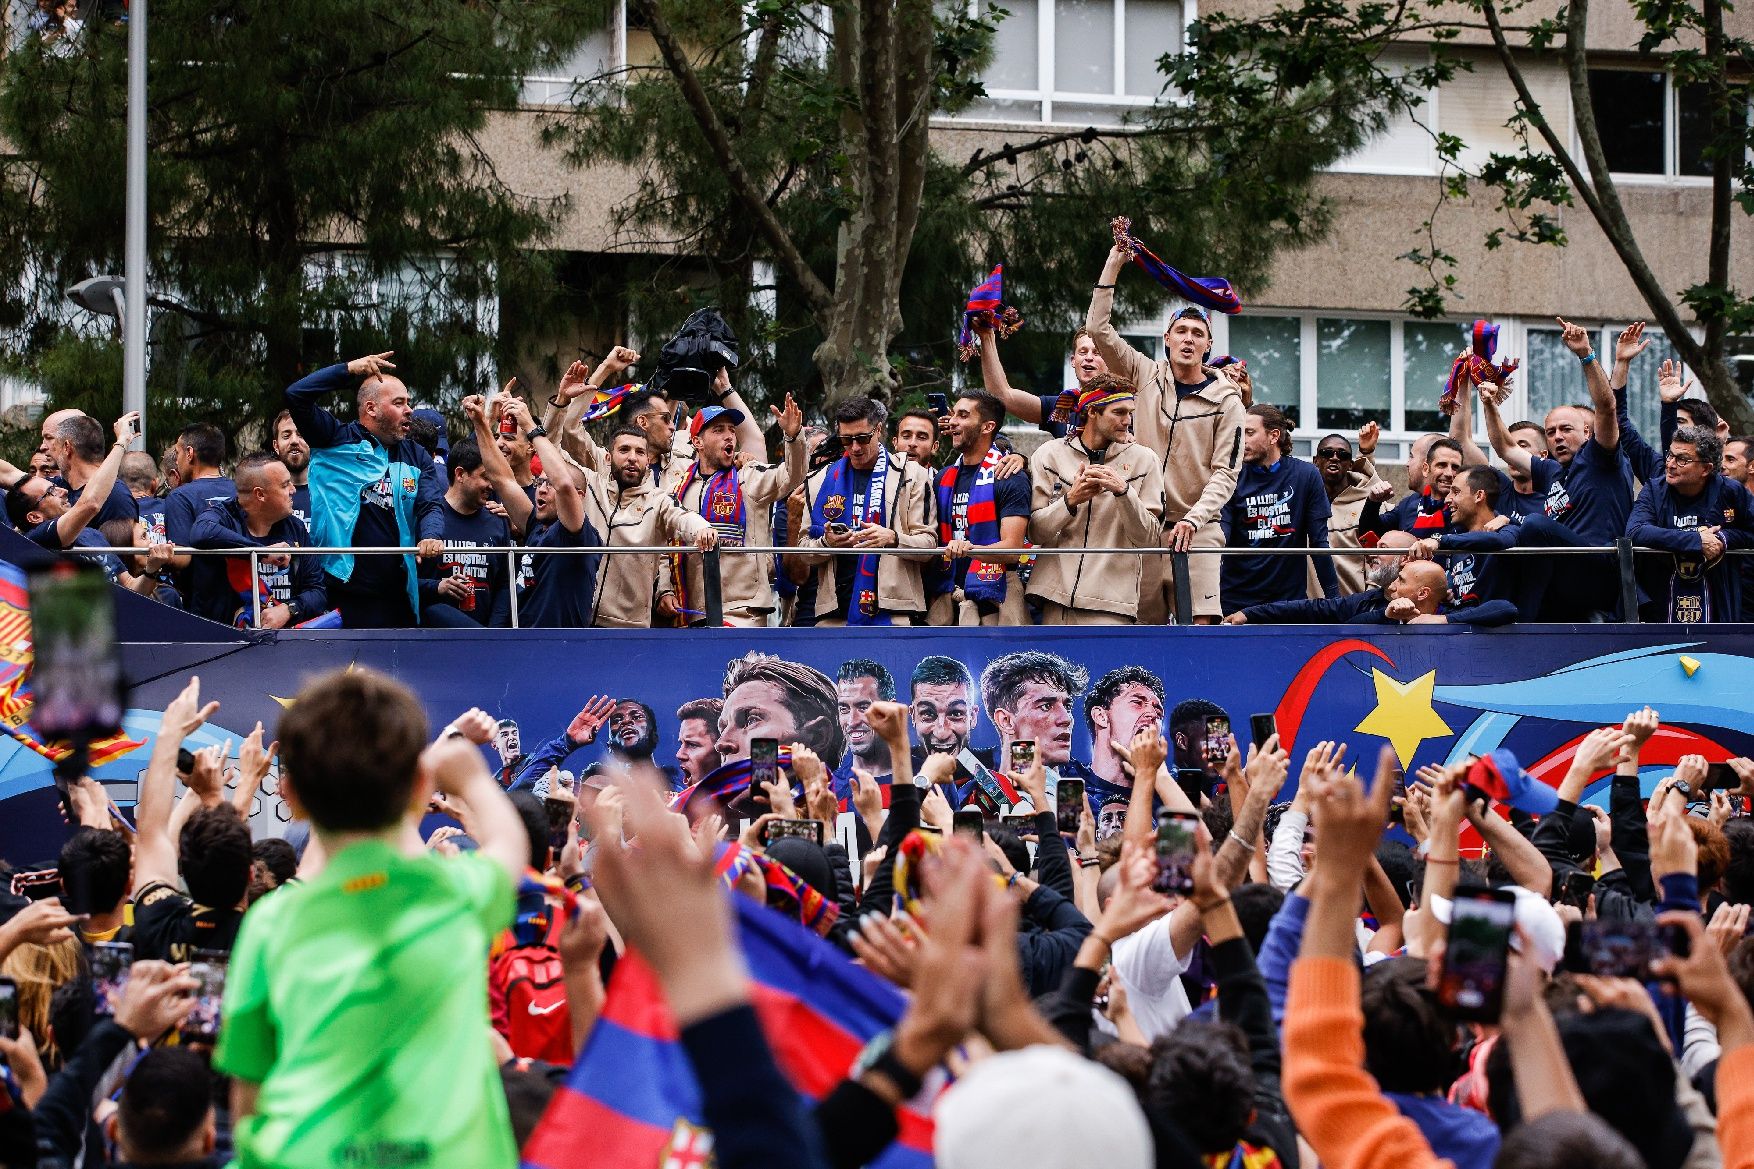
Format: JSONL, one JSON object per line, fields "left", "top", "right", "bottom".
{"left": 796, "top": 398, "right": 938, "bottom": 625}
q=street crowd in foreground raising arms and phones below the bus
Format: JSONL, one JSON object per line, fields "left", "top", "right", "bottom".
{"left": 0, "top": 655, "right": 1754, "bottom": 1169}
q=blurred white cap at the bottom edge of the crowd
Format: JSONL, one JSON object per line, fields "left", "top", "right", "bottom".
{"left": 933, "top": 1044, "right": 1154, "bottom": 1169}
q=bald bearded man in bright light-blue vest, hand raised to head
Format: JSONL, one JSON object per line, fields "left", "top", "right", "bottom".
{"left": 286, "top": 345, "right": 444, "bottom": 628}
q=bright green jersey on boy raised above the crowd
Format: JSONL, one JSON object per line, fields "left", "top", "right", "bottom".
{"left": 214, "top": 841, "right": 517, "bottom": 1169}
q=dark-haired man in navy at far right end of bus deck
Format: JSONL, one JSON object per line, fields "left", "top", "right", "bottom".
{"left": 1626, "top": 427, "right": 1754, "bottom": 625}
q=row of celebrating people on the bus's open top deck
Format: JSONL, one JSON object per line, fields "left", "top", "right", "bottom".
{"left": 0, "top": 238, "right": 1754, "bottom": 628}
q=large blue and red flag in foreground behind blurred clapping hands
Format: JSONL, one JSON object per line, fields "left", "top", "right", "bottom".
{"left": 523, "top": 897, "right": 931, "bottom": 1169}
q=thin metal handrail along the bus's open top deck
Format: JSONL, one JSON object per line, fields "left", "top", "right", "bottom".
{"left": 68, "top": 537, "right": 1711, "bottom": 628}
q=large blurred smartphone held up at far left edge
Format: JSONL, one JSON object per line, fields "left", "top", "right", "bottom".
{"left": 30, "top": 560, "right": 123, "bottom": 739}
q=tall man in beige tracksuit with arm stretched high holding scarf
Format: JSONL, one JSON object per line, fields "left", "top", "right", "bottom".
{"left": 1084, "top": 247, "right": 1251, "bottom": 625}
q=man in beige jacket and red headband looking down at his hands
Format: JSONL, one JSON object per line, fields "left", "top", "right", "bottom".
{"left": 1030, "top": 374, "right": 1163, "bottom": 625}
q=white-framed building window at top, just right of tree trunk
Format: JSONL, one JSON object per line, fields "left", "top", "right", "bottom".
{"left": 961, "top": 0, "right": 1186, "bottom": 126}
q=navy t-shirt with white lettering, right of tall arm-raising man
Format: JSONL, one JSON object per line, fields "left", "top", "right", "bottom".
{"left": 1219, "top": 458, "right": 1340, "bottom": 613}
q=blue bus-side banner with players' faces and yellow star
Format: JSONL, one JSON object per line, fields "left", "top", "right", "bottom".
{"left": 0, "top": 614, "right": 1754, "bottom": 864}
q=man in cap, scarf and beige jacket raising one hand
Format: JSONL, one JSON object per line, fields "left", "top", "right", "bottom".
{"left": 658, "top": 393, "right": 805, "bottom": 627}
